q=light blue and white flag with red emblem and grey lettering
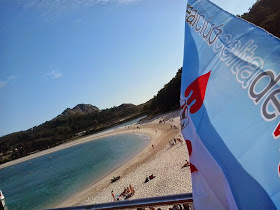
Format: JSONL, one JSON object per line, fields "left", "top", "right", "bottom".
{"left": 180, "top": 0, "right": 280, "bottom": 209}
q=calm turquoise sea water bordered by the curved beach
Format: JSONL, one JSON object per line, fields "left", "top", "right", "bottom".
{"left": 0, "top": 116, "right": 149, "bottom": 210}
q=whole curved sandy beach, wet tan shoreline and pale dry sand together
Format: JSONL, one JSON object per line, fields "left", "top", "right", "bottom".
{"left": 56, "top": 112, "right": 192, "bottom": 209}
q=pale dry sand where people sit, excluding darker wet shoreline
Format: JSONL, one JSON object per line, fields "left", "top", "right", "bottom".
{"left": 79, "top": 136, "right": 192, "bottom": 205}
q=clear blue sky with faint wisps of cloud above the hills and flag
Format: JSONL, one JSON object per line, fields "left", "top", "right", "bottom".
{"left": 0, "top": 0, "right": 255, "bottom": 136}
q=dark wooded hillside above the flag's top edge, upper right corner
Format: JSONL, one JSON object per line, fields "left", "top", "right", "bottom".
{"left": 241, "top": 0, "right": 280, "bottom": 38}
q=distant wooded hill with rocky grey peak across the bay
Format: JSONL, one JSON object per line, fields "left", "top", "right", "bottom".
{"left": 0, "top": 104, "right": 143, "bottom": 163}
